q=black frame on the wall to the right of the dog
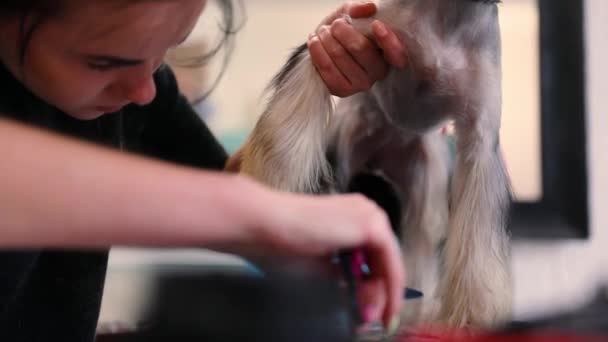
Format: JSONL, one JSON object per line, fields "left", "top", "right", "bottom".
{"left": 509, "top": 0, "right": 590, "bottom": 240}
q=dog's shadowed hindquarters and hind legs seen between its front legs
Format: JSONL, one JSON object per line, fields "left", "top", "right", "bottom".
{"left": 329, "top": 103, "right": 451, "bottom": 328}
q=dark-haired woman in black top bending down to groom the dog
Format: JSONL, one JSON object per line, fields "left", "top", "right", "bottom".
{"left": 0, "top": 0, "right": 405, "bottom": 342}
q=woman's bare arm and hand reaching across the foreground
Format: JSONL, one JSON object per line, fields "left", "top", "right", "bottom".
{"left": 0, "top": 120, "right": 404, "bottom": 325}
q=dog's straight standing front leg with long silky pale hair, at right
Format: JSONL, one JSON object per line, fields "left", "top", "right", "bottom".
{"left": 440, "top": 58, "right": 512, "bottom": 328}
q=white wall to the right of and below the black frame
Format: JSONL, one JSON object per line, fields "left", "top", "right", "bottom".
{"left": 514, "top": 0, "right": 608, "bottom": 317}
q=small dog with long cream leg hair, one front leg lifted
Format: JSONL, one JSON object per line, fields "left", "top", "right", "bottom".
{"left": 235, "top": 0, "right": 512, "bottom": 328}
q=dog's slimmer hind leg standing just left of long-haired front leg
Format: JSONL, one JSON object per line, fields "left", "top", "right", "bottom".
{"left": 401, "top": 132, "right": 451, "bottom": 326}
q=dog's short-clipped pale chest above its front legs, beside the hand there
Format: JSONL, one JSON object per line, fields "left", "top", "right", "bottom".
{"left": 355, "top": 0, "right": 501, "bottom": 131}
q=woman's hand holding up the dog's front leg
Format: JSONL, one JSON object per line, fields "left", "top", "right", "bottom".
{"left": 308, "top": 2, "right": 407, "bottom": 97}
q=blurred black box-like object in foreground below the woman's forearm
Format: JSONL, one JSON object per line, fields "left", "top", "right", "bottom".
{"left": 133, "top": 268, "right": 356, "bottom": 342}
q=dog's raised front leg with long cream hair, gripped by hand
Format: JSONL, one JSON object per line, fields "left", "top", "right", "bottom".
{"left": 241, "top": 45, "right": 334, "bottom": 193}
